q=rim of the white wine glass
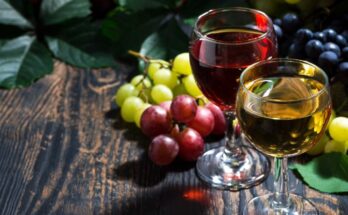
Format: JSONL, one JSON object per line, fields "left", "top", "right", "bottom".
{"left": 239, "top": 58, "right": 329, "bottom": 103}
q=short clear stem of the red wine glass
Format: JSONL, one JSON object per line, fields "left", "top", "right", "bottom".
{"left": 222, "top": 111, "right": 245, "bottom": 167}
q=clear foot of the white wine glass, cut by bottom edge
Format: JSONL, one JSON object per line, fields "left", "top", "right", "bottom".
{"left": 243, "top": 193, "right": 319, "bottom": 215}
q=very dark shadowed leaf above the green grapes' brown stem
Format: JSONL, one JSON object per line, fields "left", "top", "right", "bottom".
{"left": 102, "top": 8, "right": 166, "bottom": 56}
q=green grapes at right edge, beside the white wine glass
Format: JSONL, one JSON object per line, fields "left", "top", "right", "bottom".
{"left": 307, "top": 112, "right": 348, "bottom": 155}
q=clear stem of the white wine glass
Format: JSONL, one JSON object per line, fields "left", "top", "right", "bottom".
{"left": 272, "top": 158, "right": 290, "bottom": 208}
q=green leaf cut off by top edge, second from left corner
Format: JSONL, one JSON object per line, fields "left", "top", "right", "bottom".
{"left": 41, "top": 0, "right": 91, "bottom": 25}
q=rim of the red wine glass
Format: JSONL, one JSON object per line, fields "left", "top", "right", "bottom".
{"left": 193, "top": 7, "right": 273, "bottom": 45}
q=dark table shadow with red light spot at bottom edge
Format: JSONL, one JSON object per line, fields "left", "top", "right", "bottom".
{"left": 103, "top": 185, "right": 213, "bottom": 215}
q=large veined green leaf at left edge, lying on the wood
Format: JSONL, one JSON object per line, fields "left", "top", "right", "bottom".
{"left": 0, "top": 36, "right": 53, "bottom": 89}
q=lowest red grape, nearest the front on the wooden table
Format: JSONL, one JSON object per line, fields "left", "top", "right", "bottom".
{"left": 148, "top": 134, "right": 179, "bottom": 166}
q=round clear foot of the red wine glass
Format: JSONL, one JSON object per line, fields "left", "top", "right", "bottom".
{"left": 196, "top": 146, "right": 270, "bottom": 191}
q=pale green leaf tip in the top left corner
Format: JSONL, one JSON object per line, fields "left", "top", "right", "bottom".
{"left": 0, "top": 0, "right": 33, "bottom": 28}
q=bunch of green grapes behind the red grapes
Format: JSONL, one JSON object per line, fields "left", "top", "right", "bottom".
{"left": 115, "top": 52, "right": 205, "bottom": 127}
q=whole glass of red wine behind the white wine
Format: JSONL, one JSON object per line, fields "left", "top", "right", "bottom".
{"left": 189, "top": 8, "right": 277, "bottom": 190}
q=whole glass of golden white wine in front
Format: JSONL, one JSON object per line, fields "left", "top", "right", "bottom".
{"left": 236, "top": 59, "right": 331, "bottom": 215}
